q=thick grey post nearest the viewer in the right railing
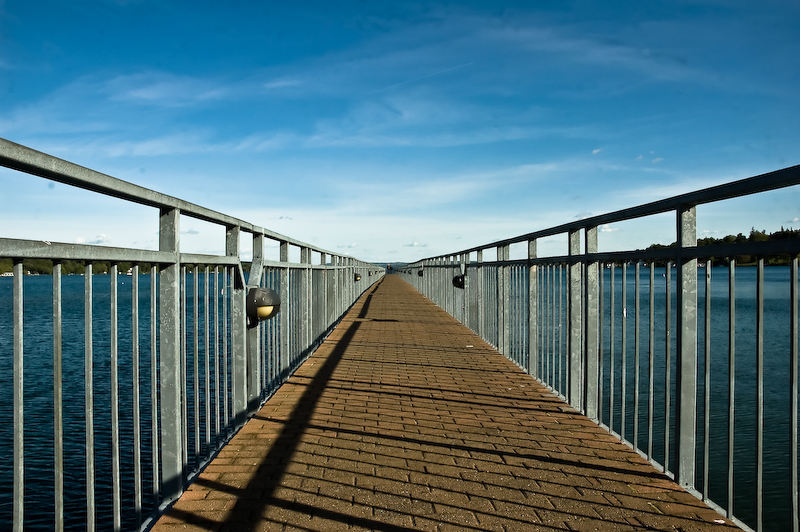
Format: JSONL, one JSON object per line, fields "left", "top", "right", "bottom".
{"left": 668, "top": 205, "right": 697, "bottom": 488}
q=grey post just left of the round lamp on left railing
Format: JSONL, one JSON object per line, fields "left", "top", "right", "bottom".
{"left": 225, "top": 226, "right": 247, "bottom": 427}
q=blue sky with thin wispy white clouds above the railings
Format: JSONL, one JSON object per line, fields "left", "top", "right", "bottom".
{"left": 0, "top": 0, "right": 800, "bottom": 261}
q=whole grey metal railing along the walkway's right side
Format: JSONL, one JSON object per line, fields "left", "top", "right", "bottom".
{"left": 399, "top": 166, "right": 800, "bottom": 532}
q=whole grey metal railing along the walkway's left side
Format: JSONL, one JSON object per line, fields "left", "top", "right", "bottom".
{"left": 0, "top": 139, "right": 384, "bottom": 531}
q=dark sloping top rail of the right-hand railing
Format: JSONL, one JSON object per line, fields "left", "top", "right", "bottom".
{"left": 414, "top": 165, "right": 800, "bottom": 264}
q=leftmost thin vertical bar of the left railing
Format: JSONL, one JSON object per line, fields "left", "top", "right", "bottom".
{"left": 13, "top": 261, "right": 25, "bottom": 532}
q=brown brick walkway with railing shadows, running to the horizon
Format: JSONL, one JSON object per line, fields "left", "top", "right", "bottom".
{"left": 154, "top": 275, "right": 738, "bottom": 532}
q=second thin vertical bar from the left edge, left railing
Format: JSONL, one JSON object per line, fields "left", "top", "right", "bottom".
{"left": 53, "top": 263, "right": 64, "bottom": 532}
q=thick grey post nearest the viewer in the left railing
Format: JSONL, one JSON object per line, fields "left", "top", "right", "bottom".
{"left": 158, "top": 209, "right": 185, "bottom": 503}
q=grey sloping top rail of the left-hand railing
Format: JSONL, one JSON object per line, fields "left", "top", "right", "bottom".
{"left": 0, "top": 138, "right": 353, "bottom": 258}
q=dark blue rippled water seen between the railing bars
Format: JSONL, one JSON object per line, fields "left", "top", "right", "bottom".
{"left": 0, "top": 267, "right": 791, "bottom": 530}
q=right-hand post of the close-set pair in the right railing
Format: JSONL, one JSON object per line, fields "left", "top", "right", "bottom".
{"left": 583, "top": 226, "right": 600, "bottom": 421}
